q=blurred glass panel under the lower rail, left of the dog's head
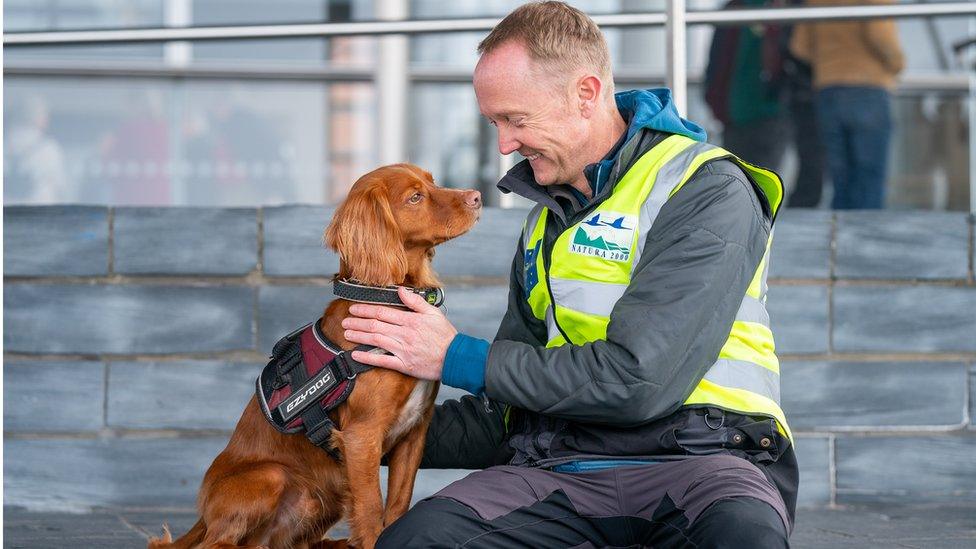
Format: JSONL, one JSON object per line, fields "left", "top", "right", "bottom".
{"left": 4, "top": 78, "right": 375, "bottom": 205}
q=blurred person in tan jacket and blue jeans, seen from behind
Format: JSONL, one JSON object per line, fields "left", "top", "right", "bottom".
{"left": 790, "top": 0, "right": 905, "bottom": 209}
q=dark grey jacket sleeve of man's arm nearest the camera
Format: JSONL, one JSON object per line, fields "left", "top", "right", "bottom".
{"left": 485, "top": 160, "right": 770, "bottom": 427}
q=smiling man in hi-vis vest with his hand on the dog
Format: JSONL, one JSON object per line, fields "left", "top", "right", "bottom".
{"left": 343, "top": 2, "right": 797, "bottom": 548}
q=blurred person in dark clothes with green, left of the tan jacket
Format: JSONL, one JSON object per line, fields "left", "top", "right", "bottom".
{"left": 705, "top": 0, "right": 790, "bottom": 170}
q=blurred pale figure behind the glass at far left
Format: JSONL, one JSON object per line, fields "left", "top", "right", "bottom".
{"left": 3, "top": 96, "right": 71, "bottom": 204}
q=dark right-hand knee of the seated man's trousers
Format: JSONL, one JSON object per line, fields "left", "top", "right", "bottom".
{"left": 689, "top": 497, "right": 789, "bottom": 549}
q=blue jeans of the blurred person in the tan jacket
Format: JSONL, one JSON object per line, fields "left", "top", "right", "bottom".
{"left": 817, "top": 86, "right": 891, "bottom": 210}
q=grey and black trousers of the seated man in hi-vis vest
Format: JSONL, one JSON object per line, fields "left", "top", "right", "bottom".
{"left": 377, "top": 455, "right": 792, "bottom": 548}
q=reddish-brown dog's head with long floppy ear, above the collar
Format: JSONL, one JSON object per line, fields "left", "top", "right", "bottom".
{"left": 325, "top": 164, "right": 481, "bottom": 285}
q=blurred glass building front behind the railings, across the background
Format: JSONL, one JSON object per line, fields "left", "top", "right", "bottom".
{"left": 3, "top": 0, "right": 976, "bottom": 209}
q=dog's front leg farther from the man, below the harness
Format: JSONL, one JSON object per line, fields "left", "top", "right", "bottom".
{"left": 333, "top": 428, "right": 385, "bottom": 549}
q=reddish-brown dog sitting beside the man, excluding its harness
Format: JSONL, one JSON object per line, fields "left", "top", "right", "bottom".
{"left": 149, "top": 164, "right": 481, "bottom": 549}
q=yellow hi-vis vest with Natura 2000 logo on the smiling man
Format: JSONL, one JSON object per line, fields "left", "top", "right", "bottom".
{"left": 522, "top": 135, "right": 792, "bottom": 440}
